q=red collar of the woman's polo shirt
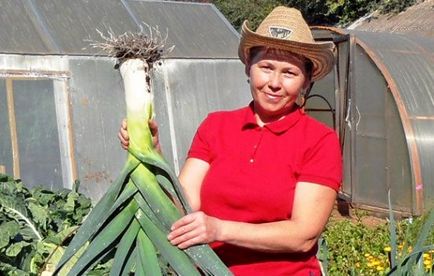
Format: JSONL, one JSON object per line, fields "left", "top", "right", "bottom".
{"left": 243, "top": 101, "right": 304, "bottom": 134}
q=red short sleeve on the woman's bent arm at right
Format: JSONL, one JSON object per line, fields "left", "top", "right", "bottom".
{"left": 298, "top": 131, "right": 342, "bottom": 191}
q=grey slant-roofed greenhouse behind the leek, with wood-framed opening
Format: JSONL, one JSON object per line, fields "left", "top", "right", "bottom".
{"left": 0, "top": 0, "right": 250, "bottom": 199}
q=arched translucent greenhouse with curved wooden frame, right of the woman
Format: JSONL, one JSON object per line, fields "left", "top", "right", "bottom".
{"left": 308, "top": 28, "right": 434, "bottom": 215}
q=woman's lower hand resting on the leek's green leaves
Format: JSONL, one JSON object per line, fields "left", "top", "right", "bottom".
{"left": 167, "top": 211, "right": 220, "bottom": 249}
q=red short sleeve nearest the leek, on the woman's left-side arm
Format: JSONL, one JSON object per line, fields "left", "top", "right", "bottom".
{"left": 187, "top": 115, "right": 212, "bottom": 163}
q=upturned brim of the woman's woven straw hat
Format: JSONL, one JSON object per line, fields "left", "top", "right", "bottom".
{"left": 238, "top": 21, "right": 335, "bottom": 81}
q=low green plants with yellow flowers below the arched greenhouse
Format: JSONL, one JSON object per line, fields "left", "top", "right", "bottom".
{"left": 322, "top": 211, "right": 434, "bottom": 275}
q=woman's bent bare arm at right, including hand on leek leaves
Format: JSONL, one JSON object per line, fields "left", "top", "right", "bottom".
{"left": 168, "top": 182, "right": 336, "bottom": 252}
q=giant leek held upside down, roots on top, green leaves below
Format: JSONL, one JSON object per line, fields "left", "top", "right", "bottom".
{"left": 55, "top": 29, "right": 231, "bottom": 276}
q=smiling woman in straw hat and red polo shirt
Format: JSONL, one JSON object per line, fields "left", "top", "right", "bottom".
{"left": 119, "top": 7, "right": 342, "bottom": 276}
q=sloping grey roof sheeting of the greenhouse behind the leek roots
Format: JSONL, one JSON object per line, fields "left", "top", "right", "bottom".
{"left": 0, "top": 0, "right": 238, "bottom": 58}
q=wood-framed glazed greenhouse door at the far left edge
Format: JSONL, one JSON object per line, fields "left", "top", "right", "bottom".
{"left": 0, "top": 77, "right": 74, "bottom": 189}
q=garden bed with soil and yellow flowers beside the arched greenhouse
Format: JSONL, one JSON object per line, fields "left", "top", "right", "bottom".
{"left": 320, "top": 202, "right": 434, "bottom": 275}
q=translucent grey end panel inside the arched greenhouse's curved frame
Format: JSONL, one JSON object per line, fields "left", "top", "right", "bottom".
{"left": 349, "top": 45, "right": 414, "bottom": 215}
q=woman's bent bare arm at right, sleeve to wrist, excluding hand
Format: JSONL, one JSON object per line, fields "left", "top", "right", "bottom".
{"left": 219, "top": 182, "right": 336, "bottom": 252}
